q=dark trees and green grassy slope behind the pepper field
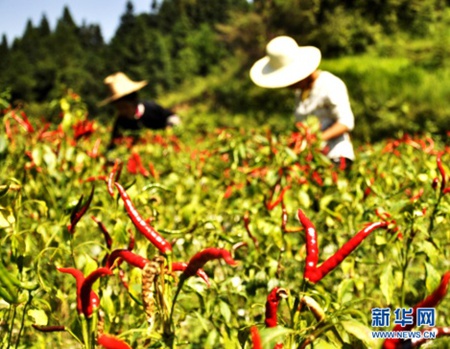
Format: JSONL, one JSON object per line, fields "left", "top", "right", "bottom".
{"left": 0, "top": 0, "right": 450, "bottom": 142}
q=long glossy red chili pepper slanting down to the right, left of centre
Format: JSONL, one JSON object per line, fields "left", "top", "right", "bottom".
{"left": 115, "top": 182, "right": 172, "bottom": 255}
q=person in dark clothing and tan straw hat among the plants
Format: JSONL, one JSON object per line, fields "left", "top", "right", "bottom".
{"left": 99, "top": 72, "right": 181, "bottom": 149}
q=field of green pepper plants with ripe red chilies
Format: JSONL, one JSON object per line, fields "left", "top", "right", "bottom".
{"left": 0, "top": 94, "right": 450, "bottom": 349}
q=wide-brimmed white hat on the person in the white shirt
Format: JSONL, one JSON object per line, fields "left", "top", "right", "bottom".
{"left": 250, "top": 36, "right": 321, "bottom": 88}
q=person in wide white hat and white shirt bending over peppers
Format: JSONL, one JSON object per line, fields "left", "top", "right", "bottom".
{"left": 250, "top": 36, "right": 355, "bottom": 168}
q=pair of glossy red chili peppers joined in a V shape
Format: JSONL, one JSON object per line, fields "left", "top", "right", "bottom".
{"left": 297, "top": 210, "right": 389, "bottom": 284}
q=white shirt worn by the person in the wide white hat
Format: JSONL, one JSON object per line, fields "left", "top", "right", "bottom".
{"left": 295, "top": 71, "right": 355, "bottom": 160}
